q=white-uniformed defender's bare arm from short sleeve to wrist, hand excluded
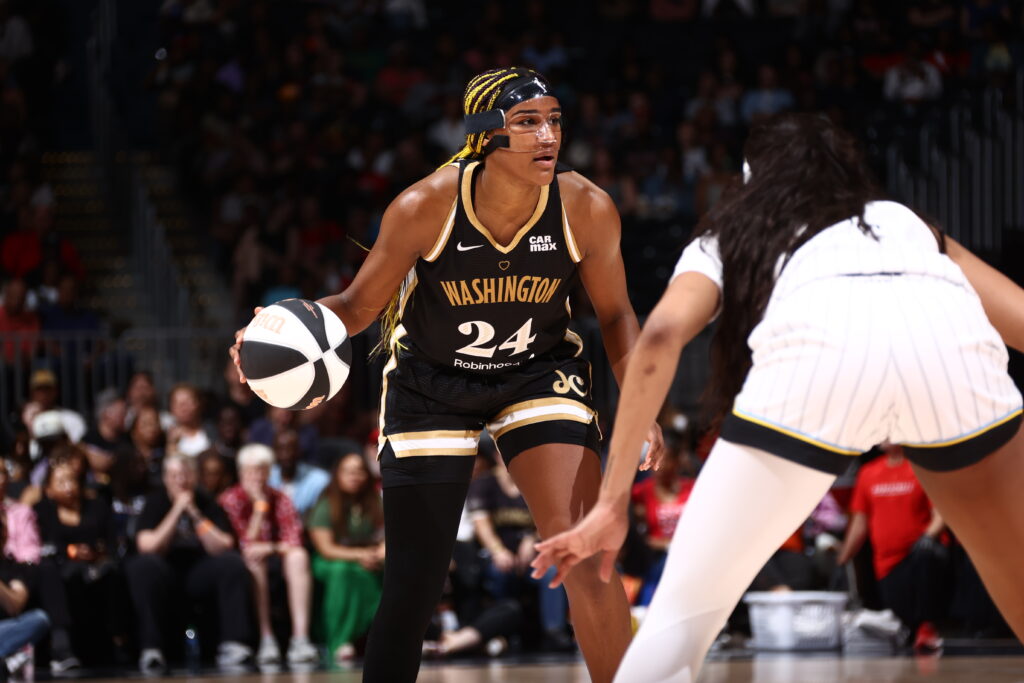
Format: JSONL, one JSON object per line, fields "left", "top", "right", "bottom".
{"left": 599, "top": 272, "right": 720, "bottom": 510}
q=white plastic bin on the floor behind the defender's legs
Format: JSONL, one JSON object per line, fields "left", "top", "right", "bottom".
{"left": 743, "top": 591, "right": 847, "bottom": 650}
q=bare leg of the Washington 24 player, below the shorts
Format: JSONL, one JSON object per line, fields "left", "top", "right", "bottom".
{"left": 509, "top": 444, "right": 632, "bottom": 681}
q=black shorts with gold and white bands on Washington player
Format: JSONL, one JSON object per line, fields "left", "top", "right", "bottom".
{"left": 378, "top": 337, "right": 601, "bottom": 487}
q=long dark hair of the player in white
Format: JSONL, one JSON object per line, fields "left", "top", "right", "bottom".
{"left": 696, "top": 114, "right": 885, "bottom": 427}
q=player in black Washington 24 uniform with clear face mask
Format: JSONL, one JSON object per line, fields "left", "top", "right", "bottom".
{"left": 231, "top": 68, "right": 662, "bottom": 683}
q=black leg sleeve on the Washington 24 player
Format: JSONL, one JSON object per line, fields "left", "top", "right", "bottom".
{"left": 362, "top": 483, "right": 469, "bottom": 683}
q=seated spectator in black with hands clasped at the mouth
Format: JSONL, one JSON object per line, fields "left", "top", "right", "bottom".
{"left": 125, "top": 455, "right": 252, "bottom": 673}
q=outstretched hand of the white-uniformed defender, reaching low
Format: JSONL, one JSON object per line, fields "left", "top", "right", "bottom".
{"left": 529, "top": 503, "right": 629, "bottom": 588}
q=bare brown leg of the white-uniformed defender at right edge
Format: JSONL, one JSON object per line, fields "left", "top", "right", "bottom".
{"left": 913, "top": 427, "right": 1024, "bottom": 641}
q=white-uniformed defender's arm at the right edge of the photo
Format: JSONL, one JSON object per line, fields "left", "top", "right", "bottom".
{"left": 945, "top": 234, "right": 1024, "bottom": 353}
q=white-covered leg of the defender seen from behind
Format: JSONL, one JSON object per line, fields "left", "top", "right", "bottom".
{"left": 615, "top": 439, "right": 836, "bottom": 683}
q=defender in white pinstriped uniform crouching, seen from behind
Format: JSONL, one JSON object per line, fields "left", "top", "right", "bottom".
{"left": 534, "top": 115, "right": 1024, "bottom": 683}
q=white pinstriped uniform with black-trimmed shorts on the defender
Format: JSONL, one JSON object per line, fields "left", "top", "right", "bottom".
{"left": 674, "top": 202, "right": 1021, "bottom": 474}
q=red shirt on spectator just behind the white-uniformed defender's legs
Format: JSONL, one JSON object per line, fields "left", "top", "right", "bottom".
{"left": 850, "top": 456, "right": 932, "bottom": 579}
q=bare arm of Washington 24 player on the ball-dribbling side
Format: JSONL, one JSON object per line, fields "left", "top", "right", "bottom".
{"left": 319, "top": 169, "right": 458, "bottom": 335}
